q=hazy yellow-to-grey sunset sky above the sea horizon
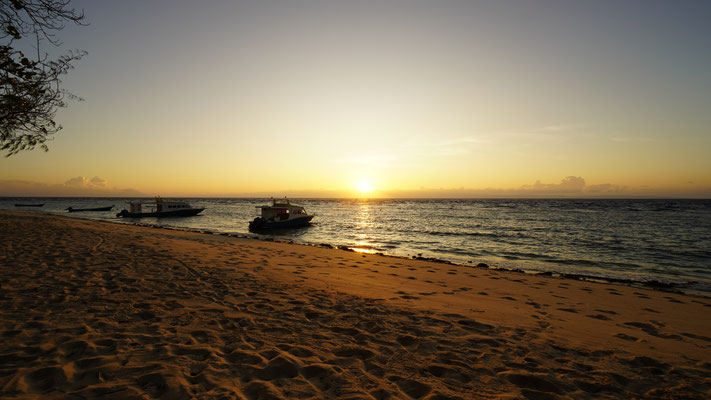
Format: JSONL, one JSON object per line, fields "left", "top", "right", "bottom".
{"left": 0, "top": 0, "right": 711, "bottom": 198}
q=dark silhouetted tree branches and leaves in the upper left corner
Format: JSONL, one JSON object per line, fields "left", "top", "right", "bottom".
{"left": 0, "top": 0, "right": 86, "bottom": 156}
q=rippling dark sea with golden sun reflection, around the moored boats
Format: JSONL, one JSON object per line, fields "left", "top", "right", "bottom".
{"left": 0, "top": 198, "right": 711, "bottom": 295}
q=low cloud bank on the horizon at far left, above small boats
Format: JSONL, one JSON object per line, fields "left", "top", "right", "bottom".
{"left": 0, "top": 176, "right": 145, "bottom": 197}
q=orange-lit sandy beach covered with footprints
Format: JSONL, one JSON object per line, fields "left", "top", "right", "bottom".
{"left": 0, "top": 211, "right": 711, "bottom": 400}
